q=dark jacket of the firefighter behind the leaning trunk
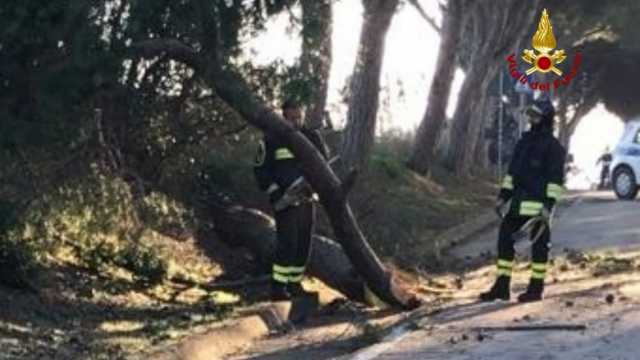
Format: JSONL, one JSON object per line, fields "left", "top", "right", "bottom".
{"left": 254, "top": 128, "right": 328, "bottom": 203}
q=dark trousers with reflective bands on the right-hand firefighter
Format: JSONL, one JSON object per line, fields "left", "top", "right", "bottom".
{"left": 498, "top": 215, "right": 551, "bottom": 280}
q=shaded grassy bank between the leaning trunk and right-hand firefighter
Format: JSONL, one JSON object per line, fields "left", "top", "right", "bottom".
{"left": 350, "top": 138, "right": 496, "bottom": 268}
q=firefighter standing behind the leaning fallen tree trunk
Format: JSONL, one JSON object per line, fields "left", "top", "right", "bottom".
{"left": 254, "top": 100, "right": 328, "bottom": 301}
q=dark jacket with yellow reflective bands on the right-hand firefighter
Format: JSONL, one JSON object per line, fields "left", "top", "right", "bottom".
{"left": 499, "top": 128, "right": 566, "bottom": 216}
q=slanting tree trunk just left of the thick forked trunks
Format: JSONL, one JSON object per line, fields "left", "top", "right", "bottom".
{"left": 409, "top": 0, "right": 465, "bottom": 174}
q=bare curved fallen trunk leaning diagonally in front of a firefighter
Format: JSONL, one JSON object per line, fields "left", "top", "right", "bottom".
{"left": 133, "top": 39, "right": 419, "bottom": 308}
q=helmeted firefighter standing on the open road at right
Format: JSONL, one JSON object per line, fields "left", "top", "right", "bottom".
{"left": 480, "top": 100, "right": 566, "bottom": 302}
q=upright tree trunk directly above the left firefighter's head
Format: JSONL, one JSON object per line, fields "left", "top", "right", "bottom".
{"left": 301, "top": 0, "right": 333, "bottom": 129}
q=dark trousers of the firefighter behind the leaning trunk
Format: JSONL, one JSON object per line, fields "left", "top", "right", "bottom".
{"left": 273, "top": 202, "right": 315, "bottom": 283}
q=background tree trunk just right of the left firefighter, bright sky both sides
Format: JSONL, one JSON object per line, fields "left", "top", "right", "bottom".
{"left": 341, "top": 0, "right": 399, "bottom": 174}
